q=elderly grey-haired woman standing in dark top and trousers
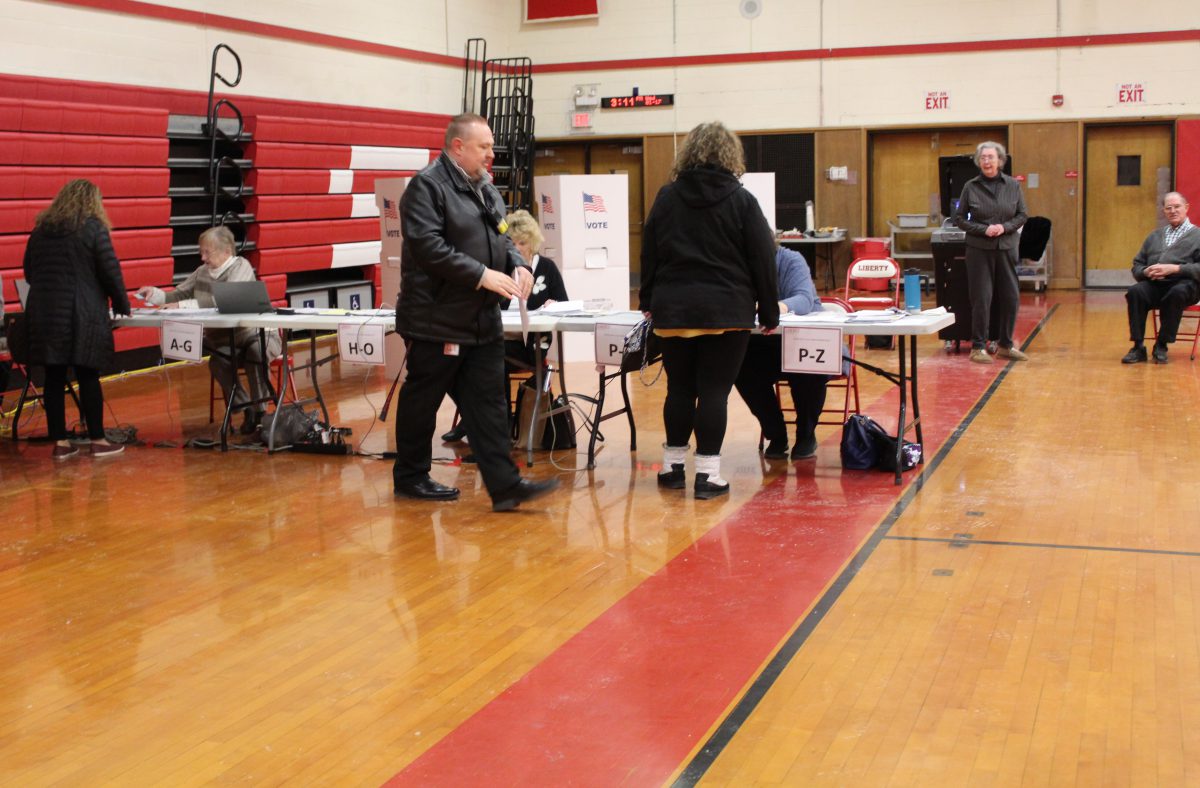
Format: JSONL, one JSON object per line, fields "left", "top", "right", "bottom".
{"left": 954, "top": 142, "right": 1028, "bottom": 363}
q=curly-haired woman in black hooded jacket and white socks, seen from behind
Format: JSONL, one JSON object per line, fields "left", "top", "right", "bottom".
{"left": 640, "top": 122, "right": 779, "bottom": 498}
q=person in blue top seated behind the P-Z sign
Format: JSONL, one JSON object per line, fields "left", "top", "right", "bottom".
{"left": 733, "top": 246, "right": 829, "bottom": 459}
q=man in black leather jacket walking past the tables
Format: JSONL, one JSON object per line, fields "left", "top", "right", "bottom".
{"left": 392, "top": 114, "right": 558, "bottom": 511}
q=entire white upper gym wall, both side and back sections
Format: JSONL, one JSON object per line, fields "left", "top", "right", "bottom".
{"left": 0, "top": 0, "right": 1200, "bottom": 131}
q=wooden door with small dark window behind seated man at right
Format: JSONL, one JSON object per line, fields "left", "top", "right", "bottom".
{"left": 1084, "top": 124, "right": 1172, "bottom": 287}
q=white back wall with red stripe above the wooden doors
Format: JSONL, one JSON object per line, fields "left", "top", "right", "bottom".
{"left": 512, "top": 0, "right": 1200, "bottom": 137}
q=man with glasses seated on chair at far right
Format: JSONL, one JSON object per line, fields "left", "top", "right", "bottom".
{"left": 1121, "top": 192, "right": 1200, "bottom": 363}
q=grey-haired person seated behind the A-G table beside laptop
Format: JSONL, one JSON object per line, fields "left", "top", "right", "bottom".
{"left": 138, "top": 227, "right": 283, "bottom": 435}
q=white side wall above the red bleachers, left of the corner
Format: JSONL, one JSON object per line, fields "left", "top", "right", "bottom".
{"left": 0, "top": 0, "right": 518, "bottom": 114}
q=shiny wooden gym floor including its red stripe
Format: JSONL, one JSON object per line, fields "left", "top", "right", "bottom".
{"left": 0, "top": 293, "right": 1200, "bottom": 786}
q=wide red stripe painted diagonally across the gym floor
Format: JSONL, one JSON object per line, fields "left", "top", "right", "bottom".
{"left": 386, "top": 299, "right": 1044, "bottom": 786}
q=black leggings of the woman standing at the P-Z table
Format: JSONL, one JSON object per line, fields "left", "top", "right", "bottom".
{"left": 661, "top": 331, "right": 750, "bottom": 455}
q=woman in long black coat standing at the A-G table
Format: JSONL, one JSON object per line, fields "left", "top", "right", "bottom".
{"left": 24, "top": 179, "right": 130, "bottom": 459}
